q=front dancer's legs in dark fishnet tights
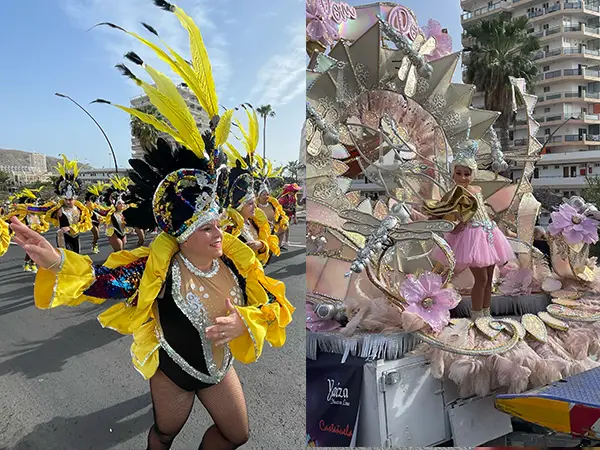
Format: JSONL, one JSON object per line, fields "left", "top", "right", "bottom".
{"left": 147, "top": 367, "right": 249, "bottom": 450}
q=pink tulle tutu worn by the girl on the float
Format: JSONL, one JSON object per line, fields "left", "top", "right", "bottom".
{"left": 433, "top": 225, "right": 515, "bottom": 272}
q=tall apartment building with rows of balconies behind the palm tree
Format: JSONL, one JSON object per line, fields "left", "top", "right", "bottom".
{"left": 461, "top": 0, "right": 600, "bottom": 196}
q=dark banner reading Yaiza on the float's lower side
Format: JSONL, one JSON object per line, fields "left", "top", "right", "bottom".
{"left": 306, "top": 353, "right": 365, "bottom": 447}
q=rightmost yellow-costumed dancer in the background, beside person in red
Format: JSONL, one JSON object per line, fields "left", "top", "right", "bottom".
{"left": 254, "top": 155, "right": 290, "bottom": 250}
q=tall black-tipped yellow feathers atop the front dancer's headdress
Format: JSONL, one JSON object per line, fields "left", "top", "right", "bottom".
{"left": 90, "top": 0, "right": 233, "bottom": 158}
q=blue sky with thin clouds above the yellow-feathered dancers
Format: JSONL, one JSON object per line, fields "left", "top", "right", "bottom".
{"left": 0, "top": 0, "right": 305, "bottom": 167}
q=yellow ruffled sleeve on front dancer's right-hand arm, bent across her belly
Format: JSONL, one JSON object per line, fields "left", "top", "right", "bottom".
{"left": 223, "top": 233, "right": 295, "bottom": 364}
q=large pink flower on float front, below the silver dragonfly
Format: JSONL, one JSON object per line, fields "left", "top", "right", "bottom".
{"left": 400, "top": 272, "right": 460, "bottom": 332}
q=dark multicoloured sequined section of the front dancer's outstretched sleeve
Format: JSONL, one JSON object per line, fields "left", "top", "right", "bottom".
{"left": 84, "top": 258, "right": 148, "bottom": 300}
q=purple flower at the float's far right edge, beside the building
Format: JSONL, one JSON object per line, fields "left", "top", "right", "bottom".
{"left": 548, "top": 203, "right": 600, "bottom": 245}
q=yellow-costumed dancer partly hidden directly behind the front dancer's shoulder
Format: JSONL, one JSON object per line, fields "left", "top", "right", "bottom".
{"left": 225, "top": 104, "right": 280, "bottom": 265}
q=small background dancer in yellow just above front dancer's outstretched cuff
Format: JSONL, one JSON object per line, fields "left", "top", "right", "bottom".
{"left": 45, "top": 155, "right": 92, "bottom": 253}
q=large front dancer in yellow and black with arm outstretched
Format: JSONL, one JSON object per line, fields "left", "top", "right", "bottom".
{"left": 12, "top": 2, "right": 294, "bottom": 450}
